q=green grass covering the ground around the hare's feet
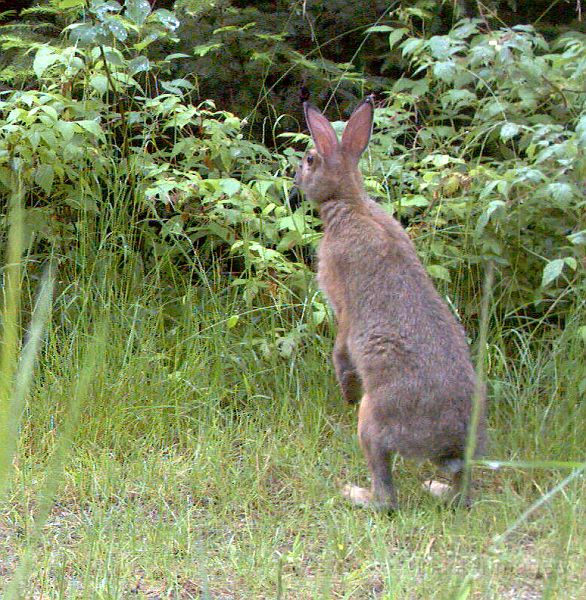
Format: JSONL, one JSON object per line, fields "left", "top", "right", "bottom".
{"left": 0, "top": 260, "right": 586, "bottom": 599}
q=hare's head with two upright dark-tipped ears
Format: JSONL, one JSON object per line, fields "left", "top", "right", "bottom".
{"left": 295, "top": 97, "right": 374, "bottom": 203}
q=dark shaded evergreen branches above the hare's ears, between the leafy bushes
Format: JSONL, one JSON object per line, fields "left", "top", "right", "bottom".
{"left": 170, "top": 0, "right": 389, "bottom": 137}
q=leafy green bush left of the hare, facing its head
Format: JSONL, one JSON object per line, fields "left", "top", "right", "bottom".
{"left": 0, "top": 0, "right": 315, "bottom": 308}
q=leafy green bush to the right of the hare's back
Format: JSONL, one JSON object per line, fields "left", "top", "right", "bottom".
{"left": 372, "top": 21, "right": 586, "bottom": 314}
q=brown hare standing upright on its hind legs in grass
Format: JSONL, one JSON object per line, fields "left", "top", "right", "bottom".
{"left": 295, "top": 100, "right": 485, "bottom": 509}
